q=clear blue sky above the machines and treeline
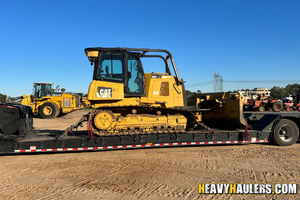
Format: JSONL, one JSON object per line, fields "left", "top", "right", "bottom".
{"left": 0, "top": 0, "right": 300, "bottom": 96}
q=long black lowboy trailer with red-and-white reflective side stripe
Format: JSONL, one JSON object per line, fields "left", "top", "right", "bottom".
{"left": 0, "top": 104, "right": 300, "bottom": 153}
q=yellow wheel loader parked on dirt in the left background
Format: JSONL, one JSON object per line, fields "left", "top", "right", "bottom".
{"left": 7, "top": 82, "right": 81, "bottom": 119}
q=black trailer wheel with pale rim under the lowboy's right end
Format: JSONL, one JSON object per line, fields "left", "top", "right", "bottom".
{"left": 272, "top": 119, "right": 299, "bottom": 146}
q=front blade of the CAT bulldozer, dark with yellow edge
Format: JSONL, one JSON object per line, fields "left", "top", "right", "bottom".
{"left": 198, "top": 92, "right": 247, "bottom": 130}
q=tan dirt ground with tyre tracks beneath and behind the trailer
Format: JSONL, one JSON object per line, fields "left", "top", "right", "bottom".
{"left": 0, "top": 110, "right": 300, "bottom": 199}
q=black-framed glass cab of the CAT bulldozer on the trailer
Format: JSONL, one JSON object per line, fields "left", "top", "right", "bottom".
{"left": 93, "top": 51, "right": 145, "bottom": 97}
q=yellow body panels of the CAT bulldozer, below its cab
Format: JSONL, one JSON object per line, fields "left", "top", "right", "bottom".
{"left": 88, "top": 73, "right": 184, "bottom": 108}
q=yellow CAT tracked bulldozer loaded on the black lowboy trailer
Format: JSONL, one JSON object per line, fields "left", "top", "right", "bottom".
{"left": 67, "top": 47, "right": 247, "bottom": 136}
